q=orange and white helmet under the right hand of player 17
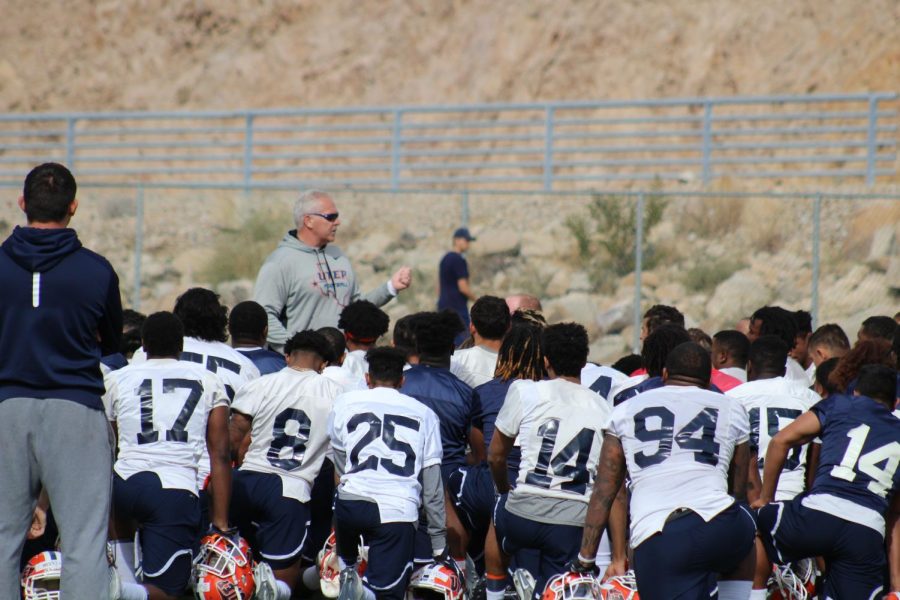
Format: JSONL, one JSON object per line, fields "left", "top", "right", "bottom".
{"left": 194, "top": 534, "right": 256, "bottom": 600}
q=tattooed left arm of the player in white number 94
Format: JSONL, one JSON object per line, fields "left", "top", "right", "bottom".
{"left": 578, "top": 433, "right": 625, "bottom": 568}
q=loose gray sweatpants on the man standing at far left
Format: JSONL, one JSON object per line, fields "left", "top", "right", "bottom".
{"left": 0, "top": 398, "right": 112, "bottom": 600}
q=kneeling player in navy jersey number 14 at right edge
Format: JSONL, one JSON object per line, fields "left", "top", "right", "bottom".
{"left": 753, "top": 365, "right": 900, "bottom": 598}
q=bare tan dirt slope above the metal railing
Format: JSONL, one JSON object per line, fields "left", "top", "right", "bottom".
{"left": 0, "top": 0, "right": 900, "bottom": 112}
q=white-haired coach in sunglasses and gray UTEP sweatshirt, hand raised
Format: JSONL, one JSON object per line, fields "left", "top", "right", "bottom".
{"left": 254, "top": 190, "right": 411, "bottom": 351}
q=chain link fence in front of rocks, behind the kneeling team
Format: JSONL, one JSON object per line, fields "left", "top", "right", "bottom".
{"left": 0, "top": 185, "right": 900, "bottom": 361}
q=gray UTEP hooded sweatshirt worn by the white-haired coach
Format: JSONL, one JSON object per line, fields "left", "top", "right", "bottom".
{"left": 253, "top": 230, "right": 394, "bottom": 350}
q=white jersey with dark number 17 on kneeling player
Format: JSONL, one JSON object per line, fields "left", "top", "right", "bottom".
{"left": 103, "top": 359, "right": 228, "bottom": 494}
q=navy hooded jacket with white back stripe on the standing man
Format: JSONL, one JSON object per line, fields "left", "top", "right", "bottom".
{"left": 0, "top": 227, "right": 122, "bottom": 410}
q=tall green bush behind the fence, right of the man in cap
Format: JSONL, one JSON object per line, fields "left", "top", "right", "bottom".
{"left": 566, "top": 194, "right": 665, "bottom": 291}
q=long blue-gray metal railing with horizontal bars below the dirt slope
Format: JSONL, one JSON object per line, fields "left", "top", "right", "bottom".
{"left": 0, "top": 93, "right": 898, "bottom": 191}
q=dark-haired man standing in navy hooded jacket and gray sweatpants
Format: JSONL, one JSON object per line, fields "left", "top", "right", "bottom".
{"left": 0, "top": 163, "right": 122, "bottom": 600}
